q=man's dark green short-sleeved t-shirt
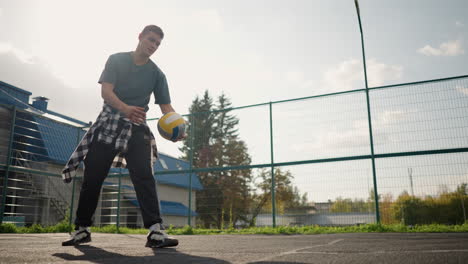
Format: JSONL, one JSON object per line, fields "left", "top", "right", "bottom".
{"left": 99, "top": 52, "right": 171, "bottom": 111}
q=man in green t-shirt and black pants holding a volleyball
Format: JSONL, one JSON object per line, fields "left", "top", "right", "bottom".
{"left": 62, "top": 25, "right": 181, "bottom": 247}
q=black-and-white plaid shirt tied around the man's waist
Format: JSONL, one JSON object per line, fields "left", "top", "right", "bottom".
{"left": 62, "top": 104, "right": 158, "bottom": 183}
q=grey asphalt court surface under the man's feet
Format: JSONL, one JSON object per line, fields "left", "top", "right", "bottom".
{"left": 0, "top": 233, "right": 468, "bottom": 264}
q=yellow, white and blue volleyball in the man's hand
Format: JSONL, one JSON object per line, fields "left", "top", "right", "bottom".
{"left": 158, "top": 112, "right": 186, "bottom": 141}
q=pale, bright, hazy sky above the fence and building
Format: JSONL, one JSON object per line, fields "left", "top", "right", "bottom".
{"left": 0, "top": 0, "right": 468, "bottom": 202}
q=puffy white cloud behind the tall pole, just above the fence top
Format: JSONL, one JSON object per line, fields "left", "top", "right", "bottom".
{"left": 324, "top": 58, "right": 403, "bottom": 91}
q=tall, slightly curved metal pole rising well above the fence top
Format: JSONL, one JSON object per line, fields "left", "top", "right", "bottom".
{"left": 354, "top": 0, "right": 380, "bottom": 224}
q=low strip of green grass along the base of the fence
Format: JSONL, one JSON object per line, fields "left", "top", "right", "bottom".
{"left": 0, "top": 222, "right": 468, "bottom": 235}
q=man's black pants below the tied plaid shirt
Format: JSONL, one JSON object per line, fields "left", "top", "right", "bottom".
{"left": 75, "top": 125, "right": 162, "bottom": 228}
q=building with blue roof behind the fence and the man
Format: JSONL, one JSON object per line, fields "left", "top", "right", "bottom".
{"left": 0, "top": 81, "right": 203, "bottom": 227}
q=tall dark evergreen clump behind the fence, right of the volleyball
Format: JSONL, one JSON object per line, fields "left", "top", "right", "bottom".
{"left": 181, "top": 91, "right": 251, "bottom": 228}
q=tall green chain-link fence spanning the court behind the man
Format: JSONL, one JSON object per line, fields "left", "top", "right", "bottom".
{"left": 0, "top": 76, "right": 468, "bottom": 228}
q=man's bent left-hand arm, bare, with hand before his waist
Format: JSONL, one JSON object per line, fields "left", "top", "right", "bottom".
{"left": 101, "top": 82, "right": 146, "bottom": 124}
